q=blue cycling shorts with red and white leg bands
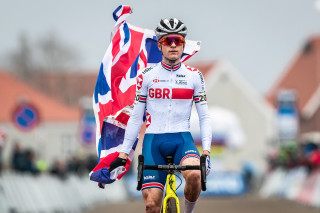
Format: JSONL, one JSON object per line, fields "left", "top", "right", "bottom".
{"left": 142, "top": 132, "right": 200, "bottom": 190}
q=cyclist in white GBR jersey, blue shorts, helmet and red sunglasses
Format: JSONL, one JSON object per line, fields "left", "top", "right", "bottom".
{"left": 110, "top": 18, "right": 212, "bottom": 213}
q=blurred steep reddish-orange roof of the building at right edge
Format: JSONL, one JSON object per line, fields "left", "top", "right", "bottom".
{"left": 267, "top": 36, "right": 320, "bottom": 140}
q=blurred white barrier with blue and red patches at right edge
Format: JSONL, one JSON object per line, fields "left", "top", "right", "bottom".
{"left": 259, "top": 167, "right": 320, "bottom": 207}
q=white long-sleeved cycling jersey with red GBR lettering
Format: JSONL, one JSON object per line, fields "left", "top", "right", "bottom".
{"left": 121, "top": 62, "right": 212, "bottom": 154}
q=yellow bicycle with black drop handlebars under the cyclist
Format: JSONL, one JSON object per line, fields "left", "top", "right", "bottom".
{"left": 137, "top": 155, "right": 207, "bottom": 213}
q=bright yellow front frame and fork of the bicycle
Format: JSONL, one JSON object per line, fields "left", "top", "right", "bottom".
{"left": 162, "top": 174, "right": 180, "bottom": 213}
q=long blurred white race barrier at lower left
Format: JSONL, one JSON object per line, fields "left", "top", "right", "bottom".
{"left": 0, "top": 172, "right": 128, "bottom": 213}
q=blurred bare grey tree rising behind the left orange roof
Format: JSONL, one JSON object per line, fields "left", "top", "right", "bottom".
{"left": 8, "top": 32, "right": 79, "bottom": 77}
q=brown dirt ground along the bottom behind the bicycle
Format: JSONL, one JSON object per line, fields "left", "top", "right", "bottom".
{"left": 86, "top": 195, "right": 320, "bottom": 213}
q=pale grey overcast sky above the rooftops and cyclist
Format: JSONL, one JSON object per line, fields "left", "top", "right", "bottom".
{"left": 0, "top": 0, "right": 320, "bottom": 93}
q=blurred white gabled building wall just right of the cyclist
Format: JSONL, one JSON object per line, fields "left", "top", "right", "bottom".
{"left": 190, "top": 60, "right": 275, "bottom": 172}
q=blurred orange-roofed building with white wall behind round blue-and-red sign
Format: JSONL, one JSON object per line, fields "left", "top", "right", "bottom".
{"left": 0, "top": 70, "right": 95, "bottom": 168}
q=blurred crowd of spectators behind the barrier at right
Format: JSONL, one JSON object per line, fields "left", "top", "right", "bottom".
{"left": 268, "top": 141, "right": 320, "bottom": 173}
